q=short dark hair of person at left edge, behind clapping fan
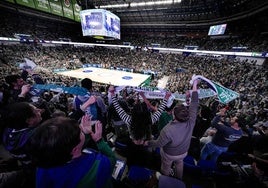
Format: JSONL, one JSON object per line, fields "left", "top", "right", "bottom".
{"left": 4, "top": 102, "right": 35, "bottom": 129}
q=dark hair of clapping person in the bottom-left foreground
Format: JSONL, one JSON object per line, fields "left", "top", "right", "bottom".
{"left": 29, "top": 117, "right": 81, "bottom": 168}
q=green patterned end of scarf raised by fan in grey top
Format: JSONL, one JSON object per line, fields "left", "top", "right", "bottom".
{"left": 211, "top": 81, "right": 239, "bottom": 104}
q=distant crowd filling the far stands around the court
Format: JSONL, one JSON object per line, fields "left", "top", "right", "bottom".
{"left": 1, "top": 44, "right": 267, "bottom": 134}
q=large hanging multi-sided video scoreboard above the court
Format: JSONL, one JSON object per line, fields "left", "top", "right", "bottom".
{"left": 80, "top": 9, "right": 120, "bottom": 39}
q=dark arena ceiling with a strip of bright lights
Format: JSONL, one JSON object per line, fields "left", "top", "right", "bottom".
{"left": 78, "top": 0, "right": 268, "bottom": 28}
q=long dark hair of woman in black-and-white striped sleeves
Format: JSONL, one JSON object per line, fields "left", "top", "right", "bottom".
{"left": 131, "top": 102, "right": 152, "bottom": 140}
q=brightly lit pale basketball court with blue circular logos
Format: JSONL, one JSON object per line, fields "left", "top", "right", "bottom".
{"left": 57, "top": 67, "right": 150, "bottom": 86}
